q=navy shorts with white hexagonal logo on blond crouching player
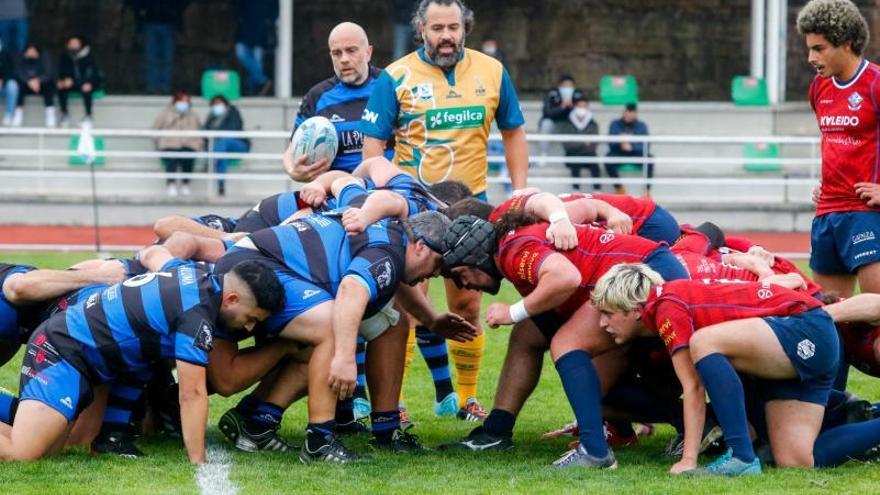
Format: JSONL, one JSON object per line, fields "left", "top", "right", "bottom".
{"left": 759, "top": 308, "right": 840, "bottom": 406}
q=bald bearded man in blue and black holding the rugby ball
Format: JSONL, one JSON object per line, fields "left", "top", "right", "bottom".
{"left": 284, "top": 22, "right": 394, "bottom": 182}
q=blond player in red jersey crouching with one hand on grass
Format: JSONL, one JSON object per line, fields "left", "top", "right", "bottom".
{"left": 591, "top": 264, "right": 880, "bottom": 476}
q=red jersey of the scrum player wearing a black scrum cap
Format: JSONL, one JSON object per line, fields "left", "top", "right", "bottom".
{"left": 495, "top": 223, "right": 660, "bottom": 316}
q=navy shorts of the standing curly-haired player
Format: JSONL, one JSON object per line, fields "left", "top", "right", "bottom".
{"left": 810, "top": 211, "right": 880, "bottom": 275}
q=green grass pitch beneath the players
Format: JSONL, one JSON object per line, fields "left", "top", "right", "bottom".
{"left": 0, "top": 253, "right": 880, "bottom": 495}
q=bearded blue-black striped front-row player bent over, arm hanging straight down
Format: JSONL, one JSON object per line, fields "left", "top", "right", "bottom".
{"left": 217, "top": 184, "right": 475, "bottom": 462}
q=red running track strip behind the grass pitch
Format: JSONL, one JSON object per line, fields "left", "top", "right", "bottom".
{"left": 0, "top": 225, "right": 810, "bottom": 253}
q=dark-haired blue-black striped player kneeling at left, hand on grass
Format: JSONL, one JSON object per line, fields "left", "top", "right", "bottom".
{"left": 0, "top": 260, "right": 283, "bottom": 462}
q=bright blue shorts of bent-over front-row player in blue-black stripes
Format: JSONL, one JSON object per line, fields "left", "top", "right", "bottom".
{"left": 214, "top": 246, "right": 333, "bottom": 336}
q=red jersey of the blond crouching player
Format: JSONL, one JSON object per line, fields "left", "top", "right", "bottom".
{"left": 642, "top": 280, "right": 822, "bottom": 354}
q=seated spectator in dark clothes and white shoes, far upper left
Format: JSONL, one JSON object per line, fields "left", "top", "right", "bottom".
{"left": 12, "top": 43, "right": 57, "bottom": 127}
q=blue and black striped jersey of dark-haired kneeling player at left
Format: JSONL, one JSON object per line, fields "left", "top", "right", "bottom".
{"left": 44, "top": 260, "right": 223, "bottom": 383}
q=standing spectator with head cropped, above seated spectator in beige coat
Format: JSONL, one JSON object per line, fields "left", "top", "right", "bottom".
{"left": 128, "top": 0, "right": 188, "bottom": 94}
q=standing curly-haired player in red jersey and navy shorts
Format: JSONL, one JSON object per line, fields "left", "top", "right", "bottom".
{"left": 797, "top": 0, "right": 880, "bottom": 297}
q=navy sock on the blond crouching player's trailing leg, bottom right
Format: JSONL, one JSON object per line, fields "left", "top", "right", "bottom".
{"left": 813, "top": 419, "right": 880, "bottom": 467}
